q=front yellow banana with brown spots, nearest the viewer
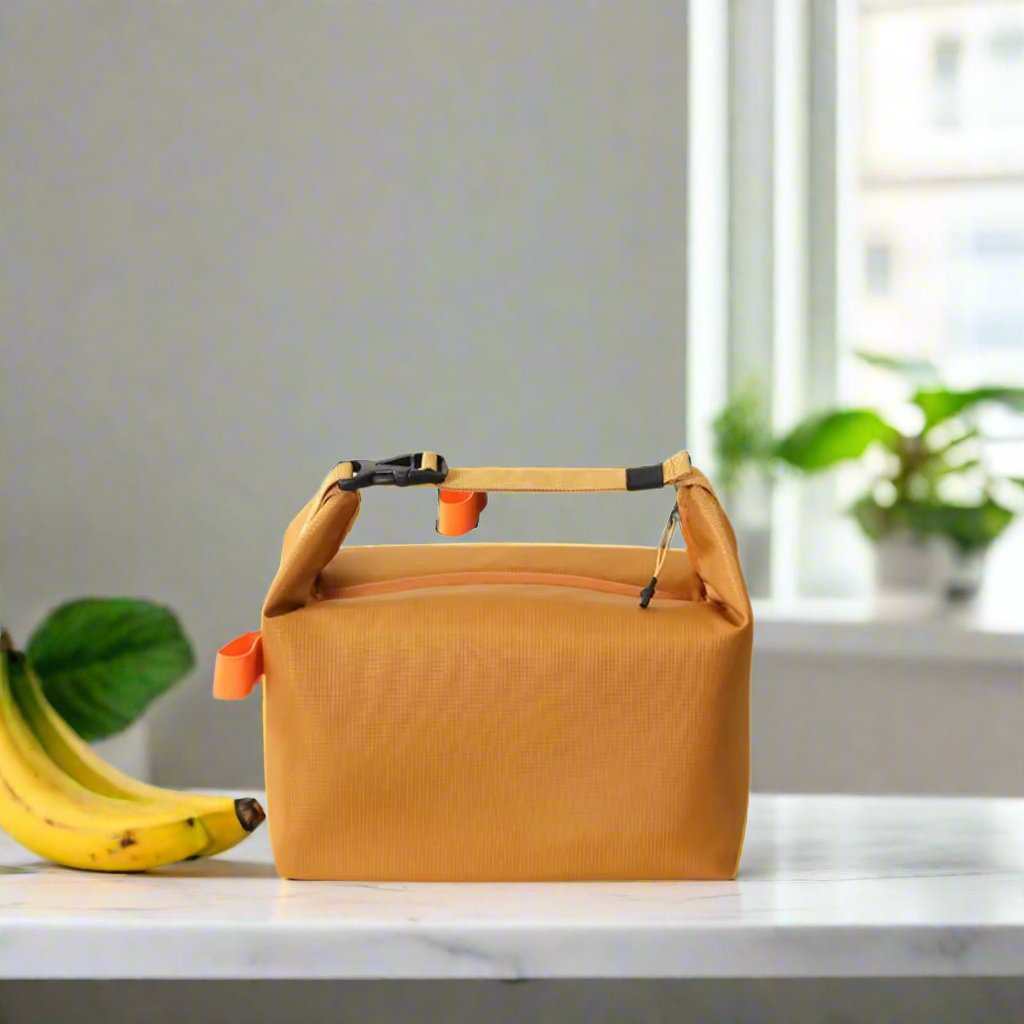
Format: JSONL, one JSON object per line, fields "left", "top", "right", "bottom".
{"left": 0, "top": 651, "right": 210, "bottom": 871}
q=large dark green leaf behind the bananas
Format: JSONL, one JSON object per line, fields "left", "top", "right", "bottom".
{"left": 26, "top": 598, "right": 195, "bottom": 740}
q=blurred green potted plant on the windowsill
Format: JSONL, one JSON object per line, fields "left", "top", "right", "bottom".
{"left": 715, "top": 352, "right": 1024, "bottom": 599}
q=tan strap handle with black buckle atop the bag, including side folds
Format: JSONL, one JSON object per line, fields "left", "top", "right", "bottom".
{"left": 263, "top": 452, "right": 751, "bottom": 620}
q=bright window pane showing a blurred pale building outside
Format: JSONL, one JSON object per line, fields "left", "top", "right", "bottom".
{"left": 848, "top": 0, "right": 1024, "bottom": 385}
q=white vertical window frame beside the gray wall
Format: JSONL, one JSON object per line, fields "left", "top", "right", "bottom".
{"left": 686, "top": 0, "right": 868, "bottom": 603}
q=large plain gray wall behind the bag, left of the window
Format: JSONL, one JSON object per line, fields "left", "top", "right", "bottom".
{"left": 0, "top": 0, "right": 685, "bottom": 785}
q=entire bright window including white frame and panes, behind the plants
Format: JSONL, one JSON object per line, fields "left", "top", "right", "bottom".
{"left": 687, "top": 0, "right": 1024, "bottom": 599}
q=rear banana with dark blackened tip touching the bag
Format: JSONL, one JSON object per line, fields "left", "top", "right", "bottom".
{"left": 11, "top": 655, "right": 266, "bottom": 857}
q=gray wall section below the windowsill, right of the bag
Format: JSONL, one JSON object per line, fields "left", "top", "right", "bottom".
{"left": 751, "top": 651, "right": 1024, "bottom": 797}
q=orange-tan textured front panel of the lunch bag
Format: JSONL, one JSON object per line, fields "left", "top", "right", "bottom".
{"left": 263, "top": 565, "right": 752, "bottom": 881}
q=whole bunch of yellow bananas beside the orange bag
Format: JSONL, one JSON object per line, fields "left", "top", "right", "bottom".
{"left": 0, "top": 634, "right": 264, "bottom": 871}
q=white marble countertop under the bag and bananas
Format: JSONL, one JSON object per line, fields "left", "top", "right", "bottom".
{"left": 0, "top": 797, "right": 1024, "bottom": 979}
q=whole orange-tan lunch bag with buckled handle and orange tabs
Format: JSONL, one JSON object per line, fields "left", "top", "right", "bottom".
{"left": 214, "top": 452, "right": 753, "bottom": 882}
